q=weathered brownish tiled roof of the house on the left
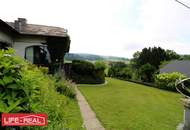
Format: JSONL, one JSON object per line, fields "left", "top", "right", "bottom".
{"left": 6, "top": 22, "right": 68, "bottom": 37}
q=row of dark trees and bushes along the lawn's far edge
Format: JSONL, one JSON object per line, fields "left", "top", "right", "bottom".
{"left": 108, "top": 47, "right": 183, "bottom": 83}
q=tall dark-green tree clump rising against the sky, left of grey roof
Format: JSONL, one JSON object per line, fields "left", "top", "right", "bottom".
{"left": 130, "top": 47, "right": 180, "bottom": 82}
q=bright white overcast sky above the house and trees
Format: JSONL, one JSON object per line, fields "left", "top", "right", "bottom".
{"left": 0, "top": 0, "right": 190, "bottom": 58}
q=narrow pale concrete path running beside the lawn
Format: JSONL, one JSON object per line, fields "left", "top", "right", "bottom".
{"left": 75, "top": 87, "right": 105, "bottom": 130}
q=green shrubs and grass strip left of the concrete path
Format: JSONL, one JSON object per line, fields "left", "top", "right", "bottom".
{"left": 0, "top": 49, "right": 82, "bottom": 130}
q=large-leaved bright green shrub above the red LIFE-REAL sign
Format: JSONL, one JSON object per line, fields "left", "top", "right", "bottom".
{"left": 0, "top": 49, "right": 39, "bottom": 113}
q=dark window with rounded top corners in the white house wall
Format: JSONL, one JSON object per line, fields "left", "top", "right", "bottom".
{"left": 25, "top": 45, "right": 51, "bottom": 66}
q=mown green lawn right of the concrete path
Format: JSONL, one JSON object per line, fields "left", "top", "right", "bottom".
{"left": 79, "top": 78, "right": 183, "bottom": 130}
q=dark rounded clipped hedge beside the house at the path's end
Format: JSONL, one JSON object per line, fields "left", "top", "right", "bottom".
{"left": 70, "top": 60, "right": 106, "bottom": 84}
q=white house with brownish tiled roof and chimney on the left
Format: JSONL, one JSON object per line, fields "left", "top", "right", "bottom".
{"left": 0, "top": 18, "right": 71, "bottom": 73}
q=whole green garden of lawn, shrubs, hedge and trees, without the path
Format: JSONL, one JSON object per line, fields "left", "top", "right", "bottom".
{"left": 0, "top": 48, "right": 186, "bottom": 130}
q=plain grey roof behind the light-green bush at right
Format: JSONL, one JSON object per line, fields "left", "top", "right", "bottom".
{"left": 160, "top": 60, "right": 190, "bottom": 77}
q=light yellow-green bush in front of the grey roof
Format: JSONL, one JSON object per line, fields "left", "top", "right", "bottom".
{"left": 155, "top": 72, "right": 186, "bottom": 91}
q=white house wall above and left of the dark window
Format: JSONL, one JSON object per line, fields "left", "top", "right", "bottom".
{"left": 13, "top": 36, "right": 46, "bottom": 58}
